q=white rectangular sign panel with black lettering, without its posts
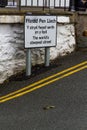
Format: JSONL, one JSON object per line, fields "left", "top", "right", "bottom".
{"left": 25, "top": 15, "right": 57, "bottom": 48}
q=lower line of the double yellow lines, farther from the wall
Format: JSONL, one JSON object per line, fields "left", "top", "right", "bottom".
{"left": 0, "top": 65, "right": 87, "bottom": 103}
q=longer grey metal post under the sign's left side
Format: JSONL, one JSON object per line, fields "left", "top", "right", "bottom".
{"left": 26, "top": 49, "right": 31, "bottom": 76}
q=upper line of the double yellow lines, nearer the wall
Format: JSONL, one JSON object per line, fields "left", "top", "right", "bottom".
{"left": 0, "top": 61, "right": 87, "bottom": 100}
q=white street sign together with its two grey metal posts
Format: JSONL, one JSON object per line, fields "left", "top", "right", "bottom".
{"left": 25, "top": 15, "right": 57, "bottom": 76}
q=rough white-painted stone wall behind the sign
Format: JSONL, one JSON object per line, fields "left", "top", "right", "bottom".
{"left": 0, "top": 16, "right": 76, "bottom": 83}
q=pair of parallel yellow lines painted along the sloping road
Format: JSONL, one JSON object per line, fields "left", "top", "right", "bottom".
{"left": 0, "top": 61, "right": 87, "bottom": 103}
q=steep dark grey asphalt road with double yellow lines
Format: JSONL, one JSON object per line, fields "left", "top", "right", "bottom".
{"left": 0, "top": 51, "right": 87, "bottom": 130}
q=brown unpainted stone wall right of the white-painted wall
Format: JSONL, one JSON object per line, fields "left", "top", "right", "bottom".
{"left": 76, "top": 12, "right": 87, "bottom": 47}
